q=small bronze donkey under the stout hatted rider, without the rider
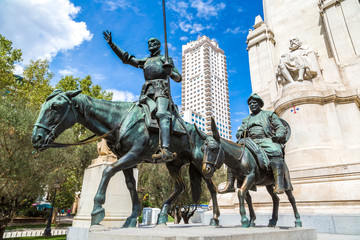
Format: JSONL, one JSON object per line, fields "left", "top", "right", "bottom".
{"left": 196, "top": 119, "right": 302, "bottom": 227}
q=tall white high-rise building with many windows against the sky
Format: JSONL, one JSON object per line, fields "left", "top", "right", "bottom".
{"left": 181, "top": 36, "right": 231, "bottom": 139}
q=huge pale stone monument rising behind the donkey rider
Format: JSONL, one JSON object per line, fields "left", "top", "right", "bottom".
{"left": 211, "top": 0, "right": 360, "bottom": 234}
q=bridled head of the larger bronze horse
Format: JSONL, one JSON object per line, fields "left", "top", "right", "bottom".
{"left": 31, "top": 89, "right": 81, "bottom": 151}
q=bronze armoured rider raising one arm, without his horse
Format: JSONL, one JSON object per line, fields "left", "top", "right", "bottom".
{"left": 103, "top": 31, "right": 181, "bottom": 162}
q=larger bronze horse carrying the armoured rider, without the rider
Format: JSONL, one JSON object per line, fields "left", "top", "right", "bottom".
{"left": 32, "top": 90, "right": 220, "bottom": 227}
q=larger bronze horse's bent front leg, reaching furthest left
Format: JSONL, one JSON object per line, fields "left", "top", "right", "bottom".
{"left": 91, "top": 149, "right": 139, "bottom": 225}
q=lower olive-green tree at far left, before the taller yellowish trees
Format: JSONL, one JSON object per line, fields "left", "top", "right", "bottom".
{"left": 0, "top": 95, "right": 78, "bottom": 236}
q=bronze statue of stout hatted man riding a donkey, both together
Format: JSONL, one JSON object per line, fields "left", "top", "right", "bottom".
{"left": 199, "top": 94, "right": 302, "bottom": 227}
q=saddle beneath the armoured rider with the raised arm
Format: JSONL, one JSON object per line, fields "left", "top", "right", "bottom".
{"left": 139, "top": 97, "right": 187, "bottom": 135}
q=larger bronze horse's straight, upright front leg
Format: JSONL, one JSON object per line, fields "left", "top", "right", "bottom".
{"left": 122, "top": 168, "right": 141, "bottom": 228}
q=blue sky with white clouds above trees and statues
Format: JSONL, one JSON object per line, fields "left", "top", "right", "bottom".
{"left": 0, "top": 0, "right": 263, "bottom": 140}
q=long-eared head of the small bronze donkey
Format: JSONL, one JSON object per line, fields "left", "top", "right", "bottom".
{"left": 195, "top": 118, "right": 225, "bottom": 179}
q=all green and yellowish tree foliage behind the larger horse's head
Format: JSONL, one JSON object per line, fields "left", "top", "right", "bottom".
{"left": 0, "top": 35, "right": 112, "bottom": 238}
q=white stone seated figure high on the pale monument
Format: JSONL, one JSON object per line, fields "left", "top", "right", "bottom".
{"left": 276, "top": 37, "right": 317, "bottom": 84}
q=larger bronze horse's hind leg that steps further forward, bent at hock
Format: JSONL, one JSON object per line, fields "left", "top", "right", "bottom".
{"left": 156, "top": 162, "right": 185, "bottom": 225}
